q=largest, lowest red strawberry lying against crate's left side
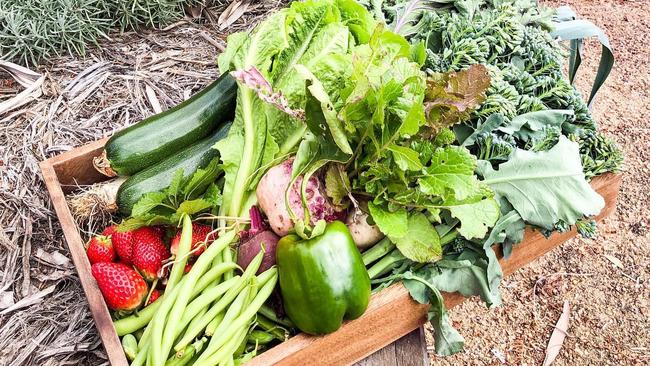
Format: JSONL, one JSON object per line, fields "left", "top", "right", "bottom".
{"left": 91, "top": 262, "right": 148, "bottom": 311}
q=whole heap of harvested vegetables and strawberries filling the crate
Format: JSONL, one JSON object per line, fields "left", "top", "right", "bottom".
{"left": 57, "top": 0, "right": 621, "bottom": 365}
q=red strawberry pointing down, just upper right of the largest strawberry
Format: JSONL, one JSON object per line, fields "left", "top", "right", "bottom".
{"left": 133, "top": 227, "right": 169, "bottom": 281}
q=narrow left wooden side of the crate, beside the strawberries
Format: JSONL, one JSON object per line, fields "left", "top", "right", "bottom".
{"left": 40, "top": 161, "right": 128, "bottom": 366}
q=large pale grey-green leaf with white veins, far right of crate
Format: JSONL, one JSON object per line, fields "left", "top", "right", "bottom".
{"left": 479, "top": 136, "right": 605, "bottom": 230}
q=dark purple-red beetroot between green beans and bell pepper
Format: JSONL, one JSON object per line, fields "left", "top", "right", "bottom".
{"left": 237, "top": 206, "right": 280, "bottom": 274}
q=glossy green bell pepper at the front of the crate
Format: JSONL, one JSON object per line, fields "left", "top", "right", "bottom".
{"left": 276, "top": 221, "right": 370, "bottom": 334}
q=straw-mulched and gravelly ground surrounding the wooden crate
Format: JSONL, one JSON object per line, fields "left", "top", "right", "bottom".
{"left": 0, "top": 0, "right": 650, "bottom": 366}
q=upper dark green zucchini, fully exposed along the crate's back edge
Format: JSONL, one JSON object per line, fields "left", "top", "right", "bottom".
{"left": 104, "top": 73, "right": 237, "bottom": 176}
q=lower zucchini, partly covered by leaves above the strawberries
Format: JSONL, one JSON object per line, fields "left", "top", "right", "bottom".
{"left": 117, "top": 122, "right": 232, "bottom": 216}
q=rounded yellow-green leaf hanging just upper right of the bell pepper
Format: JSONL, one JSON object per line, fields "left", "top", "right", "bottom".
{"left": 390, "top": 212, "right": 442, "bottom": 263}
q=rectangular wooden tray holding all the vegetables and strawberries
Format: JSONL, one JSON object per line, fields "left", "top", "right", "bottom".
{"left": 40, "top": 139, "right": 621, "bottom": 366}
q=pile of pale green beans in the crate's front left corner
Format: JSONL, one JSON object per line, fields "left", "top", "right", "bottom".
{"left": 114, "top": 217, "right": 289, "bottom": 366}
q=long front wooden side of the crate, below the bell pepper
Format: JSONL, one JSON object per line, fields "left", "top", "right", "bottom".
{"left": 246, "top": 174, "right": 621, "bottom": 366}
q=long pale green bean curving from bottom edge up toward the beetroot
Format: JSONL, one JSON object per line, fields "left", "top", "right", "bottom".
{"left": 156, "top": 230, "right": 236, "bottom": 366}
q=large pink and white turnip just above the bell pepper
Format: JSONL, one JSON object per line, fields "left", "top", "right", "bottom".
{"left": 256, "top": 159, "right": 346, "bottom": 236}
